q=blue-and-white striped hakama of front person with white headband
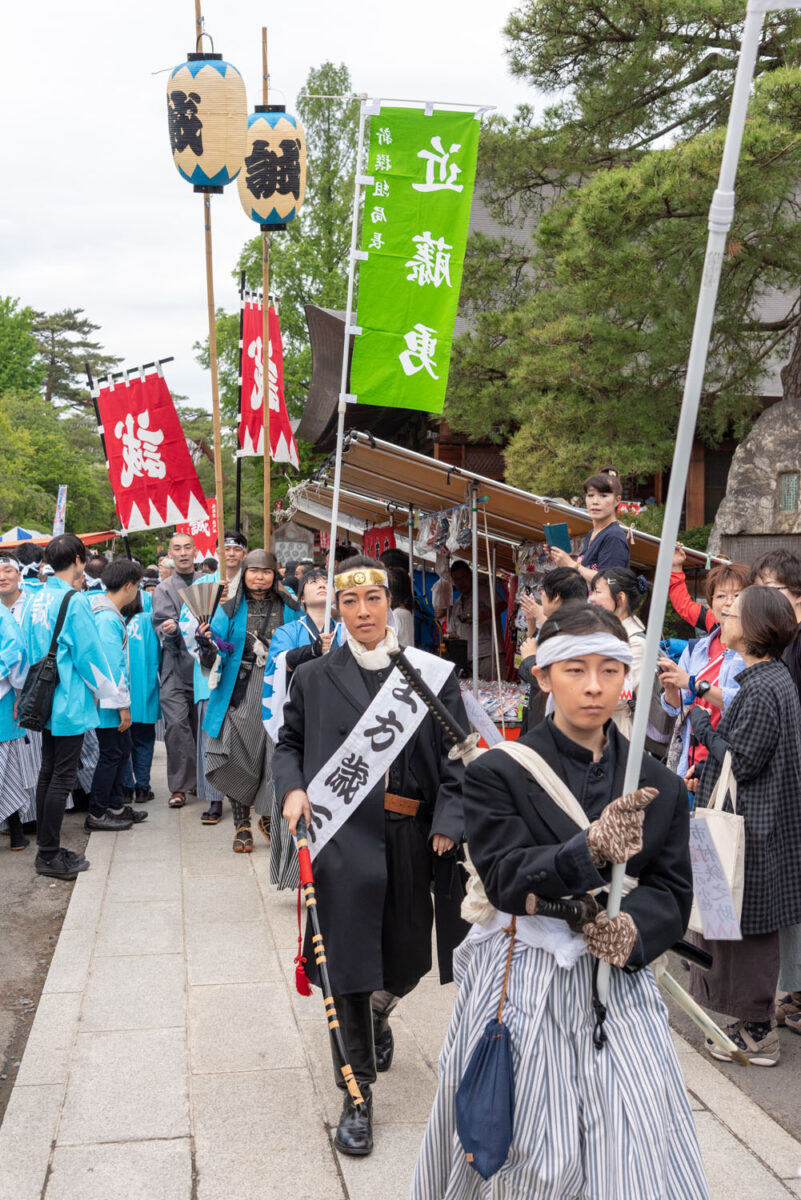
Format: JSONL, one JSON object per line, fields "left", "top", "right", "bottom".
{"left": 410, "top": 934, "right": 709, "bottom": 1200}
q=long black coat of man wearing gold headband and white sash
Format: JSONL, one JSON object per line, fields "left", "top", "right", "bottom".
{"left": 272, "top": 643, "right": 468, "bottom": 996}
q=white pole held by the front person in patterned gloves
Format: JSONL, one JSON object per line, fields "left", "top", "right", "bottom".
{"left": 598, "top": 0, "right": 767, "bottom": 1004}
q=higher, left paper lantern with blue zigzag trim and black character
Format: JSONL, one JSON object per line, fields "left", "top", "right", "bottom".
{"left": 167, "top": 54, "right": 247, "bottom": 192}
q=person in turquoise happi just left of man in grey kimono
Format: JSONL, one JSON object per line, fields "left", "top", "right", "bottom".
{"left": 121, "top": 575, "right": 162, "bottom": 804}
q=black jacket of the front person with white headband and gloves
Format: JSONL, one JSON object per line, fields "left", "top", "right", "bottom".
{"left": 463, "top": 719, "right": 693, "bottom": 970}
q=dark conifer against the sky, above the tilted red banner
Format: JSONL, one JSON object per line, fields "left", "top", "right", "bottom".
{"left": 32, "top": 308, "right": 121, "bottom": 408}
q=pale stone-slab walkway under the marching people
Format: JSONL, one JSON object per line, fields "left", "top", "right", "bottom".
{"left": 0, "top": 746, "right": 801, "bottom": 1200}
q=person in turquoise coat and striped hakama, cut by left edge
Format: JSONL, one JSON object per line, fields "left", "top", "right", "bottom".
{"left": 0, "top": 604, "right": 36, "bottom": 850}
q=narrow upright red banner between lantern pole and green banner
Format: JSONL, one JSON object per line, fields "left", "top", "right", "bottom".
{"left": 239, "top": 298, "right": 300, "bottom": 467}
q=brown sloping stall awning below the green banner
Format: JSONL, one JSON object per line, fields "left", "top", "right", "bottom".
{"left": 282, "top": 432, "right": 721, "bottom": 571}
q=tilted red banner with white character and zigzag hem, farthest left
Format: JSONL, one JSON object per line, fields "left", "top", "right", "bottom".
{"left": 97, "top": 373, "right": 207, "bottom": 533}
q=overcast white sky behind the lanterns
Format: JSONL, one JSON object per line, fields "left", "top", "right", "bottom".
{"left": 6, "top": 0, "right": 532, "bottom": 407}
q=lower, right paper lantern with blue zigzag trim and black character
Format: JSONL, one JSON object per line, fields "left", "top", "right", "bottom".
{"left": 236, "top": 104, "right": 306, "bottom": 233}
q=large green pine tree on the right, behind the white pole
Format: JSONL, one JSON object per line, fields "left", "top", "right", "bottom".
{"left": 446, "top": 0, "right": 801, "bottom": 494}
